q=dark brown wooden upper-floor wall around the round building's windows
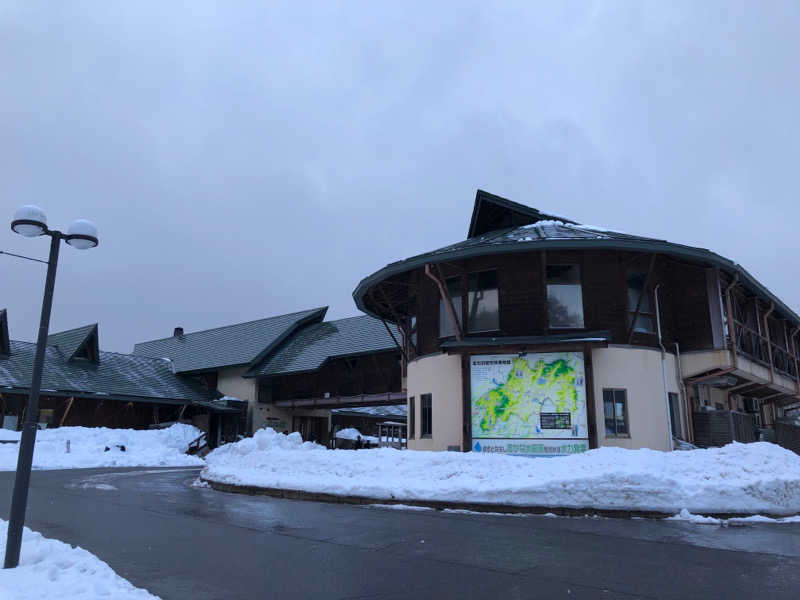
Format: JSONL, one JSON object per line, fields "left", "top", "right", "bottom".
{"left": 410, "top": 250, "right": 713, "bottom": 355}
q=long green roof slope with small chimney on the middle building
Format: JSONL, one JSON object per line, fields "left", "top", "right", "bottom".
{"left": 133, "top": 306, "right": 328, "bottom": 373}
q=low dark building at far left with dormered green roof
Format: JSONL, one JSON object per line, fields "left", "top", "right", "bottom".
{"left": 0, "top": 310, "right": 240, "bottom": 438}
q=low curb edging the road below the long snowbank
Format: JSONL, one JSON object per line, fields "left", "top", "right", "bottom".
{"left": 200, "top": 477, "right": 793, "bottom": 519}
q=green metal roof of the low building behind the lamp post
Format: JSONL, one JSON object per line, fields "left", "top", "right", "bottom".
{"left": 0, "top": 340, "right": 216, "bottom": 404}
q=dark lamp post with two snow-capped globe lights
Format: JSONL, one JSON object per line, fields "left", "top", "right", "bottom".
{"left": 3, "top": 205, "right": 98, "bottom": 569}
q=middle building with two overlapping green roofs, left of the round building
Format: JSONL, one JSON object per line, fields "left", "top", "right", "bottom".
{"left": 134, "top": 307, "right": 406, "bottom": 443}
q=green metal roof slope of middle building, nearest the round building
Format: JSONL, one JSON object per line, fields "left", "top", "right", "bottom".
{"left": 244, "top": 315, "right": 400, "bottom": 377}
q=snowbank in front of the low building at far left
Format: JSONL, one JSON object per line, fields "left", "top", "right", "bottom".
{"left": 0, "top": 423, "right": 203, "bottom": 471}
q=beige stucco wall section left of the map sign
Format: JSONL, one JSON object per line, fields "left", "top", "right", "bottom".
{"left": 407, "top": 354, "right": 464, "bottom": 450}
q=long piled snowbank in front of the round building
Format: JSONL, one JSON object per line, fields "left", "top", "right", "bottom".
{"left": 202, "top": 429, "right": 800, "bottom": 515}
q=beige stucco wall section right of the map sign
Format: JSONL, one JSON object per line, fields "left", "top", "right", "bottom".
{"left": 592, "top": 346, "right": 686, "bottom": 450}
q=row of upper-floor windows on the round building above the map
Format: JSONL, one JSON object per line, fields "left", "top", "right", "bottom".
{"left": 439, "top": 265, "right": 655, "bottom": 338}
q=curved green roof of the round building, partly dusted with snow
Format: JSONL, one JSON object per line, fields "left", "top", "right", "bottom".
{"left": 353, "top": 192, "right": 800, "bottom": 324}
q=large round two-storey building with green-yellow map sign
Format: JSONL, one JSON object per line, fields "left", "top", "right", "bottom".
{"left": 353, "top": 191, "right": 800, "bottom": 455}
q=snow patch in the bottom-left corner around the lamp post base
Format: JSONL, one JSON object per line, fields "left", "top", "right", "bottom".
{"left": 0, "top": 519, "right": 158, "bottom": 600}
